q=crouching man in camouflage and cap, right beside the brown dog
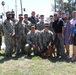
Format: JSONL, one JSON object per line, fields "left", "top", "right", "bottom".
{"left": 40, "top": 23, "right": 54, "bottom": 57}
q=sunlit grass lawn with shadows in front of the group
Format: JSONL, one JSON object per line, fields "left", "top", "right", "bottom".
{"left": 0, "top": 45, "right": 76, "bottom": 75}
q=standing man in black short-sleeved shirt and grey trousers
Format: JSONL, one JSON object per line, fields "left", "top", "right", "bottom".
{"left": 53, "top": 12, "right": 67, "bottom": 59}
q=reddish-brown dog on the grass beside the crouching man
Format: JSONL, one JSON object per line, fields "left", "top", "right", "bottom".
{"left": 41, "top": 45, "right": 55, "bottom": 58}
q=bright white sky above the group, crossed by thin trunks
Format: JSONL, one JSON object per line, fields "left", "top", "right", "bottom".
{"left": 0, "top": 0, "right": 66, "bottom": 17}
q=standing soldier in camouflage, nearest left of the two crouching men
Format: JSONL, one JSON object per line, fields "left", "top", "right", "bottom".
{"left": 15, "top": 14, "right": 25, "bottom": 55}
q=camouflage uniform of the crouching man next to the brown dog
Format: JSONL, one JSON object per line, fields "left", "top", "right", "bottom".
{"left": 41, "top": 23, "right": 54, "bottom": 53}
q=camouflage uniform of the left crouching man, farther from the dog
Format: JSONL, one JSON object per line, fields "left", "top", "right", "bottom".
{"left": 25, "top": 30, "right": 40, "bottom": 56}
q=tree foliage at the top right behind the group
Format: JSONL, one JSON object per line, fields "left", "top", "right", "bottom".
{"left": 53, "top": 0, "right": 76, "bottom": 14}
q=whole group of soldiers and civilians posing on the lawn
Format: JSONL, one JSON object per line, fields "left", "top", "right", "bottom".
{"left": 0, "top": 11, "right": 76, "bottom": 60}
